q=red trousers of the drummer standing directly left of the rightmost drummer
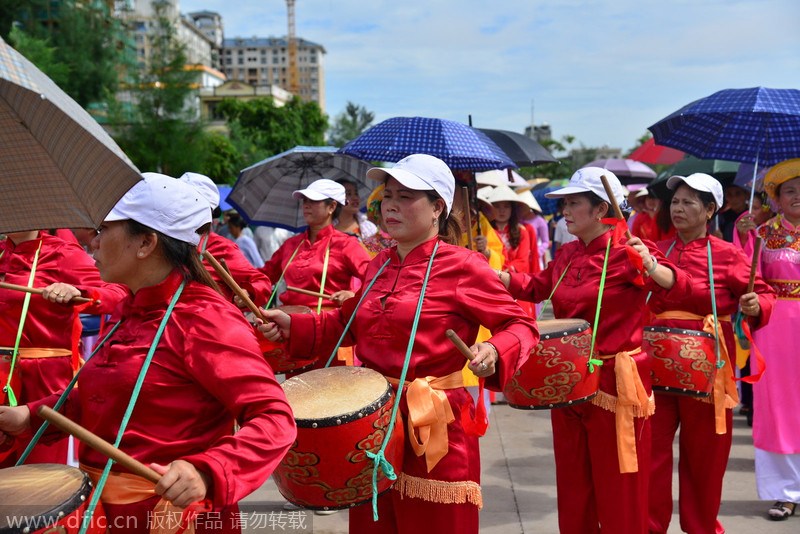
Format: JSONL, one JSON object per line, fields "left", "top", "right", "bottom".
{"left": 551, "top": 402, "right": 650, "bottom": 534}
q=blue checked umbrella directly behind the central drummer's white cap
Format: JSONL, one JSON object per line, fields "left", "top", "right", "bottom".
{"left": 339, "top": 117, "right": 516, "bottom": 171}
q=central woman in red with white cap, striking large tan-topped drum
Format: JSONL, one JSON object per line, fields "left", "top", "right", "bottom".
{"left": 260, "top": 154, "right": 538, "bottom": 534}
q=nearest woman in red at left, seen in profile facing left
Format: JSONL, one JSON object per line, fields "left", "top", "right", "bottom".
{"left": 0, "top": 174, "right": 295, "bottom": 533}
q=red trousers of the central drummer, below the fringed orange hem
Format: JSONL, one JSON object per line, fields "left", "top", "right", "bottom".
{"left": 350, "top": 490, "right": 480, "bottom": 534}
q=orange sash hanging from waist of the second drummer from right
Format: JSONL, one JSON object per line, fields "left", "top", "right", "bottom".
{"left": 600, "top": 347, "right": 650, "bottom": 473}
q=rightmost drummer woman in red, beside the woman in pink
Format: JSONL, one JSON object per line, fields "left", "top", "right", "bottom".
{"left": 648, "top": 173, "right": 775, "bottom": 534}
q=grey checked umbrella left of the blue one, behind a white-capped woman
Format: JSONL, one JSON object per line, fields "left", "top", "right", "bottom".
{"left": 227, "top": 146, "right": 377, "bottom": 232}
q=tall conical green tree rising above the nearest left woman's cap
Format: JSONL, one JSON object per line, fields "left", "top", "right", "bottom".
{"left": 112, "top": 1, "right": 206, "bottom": 176}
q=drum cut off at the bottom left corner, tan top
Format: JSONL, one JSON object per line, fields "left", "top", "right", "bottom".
{"left": 0, "top": 464, "right": 107, "bottom": 534}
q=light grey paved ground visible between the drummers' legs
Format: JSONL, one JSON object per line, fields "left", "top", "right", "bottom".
{"left": 243, "top": 406, "right": 800, "bottom": 534}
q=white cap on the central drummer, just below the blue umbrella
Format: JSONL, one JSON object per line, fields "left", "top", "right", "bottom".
{"left": 367, "top": 154, "right": 456, "bottom": 215}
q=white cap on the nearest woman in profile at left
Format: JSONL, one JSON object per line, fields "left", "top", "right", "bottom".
{"left": 105, "top": 172, "right": 211, "bottom": 245}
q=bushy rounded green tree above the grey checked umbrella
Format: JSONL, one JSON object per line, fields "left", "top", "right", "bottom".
{"left": 217, "top": 97, "right": 328, "bottom": 166}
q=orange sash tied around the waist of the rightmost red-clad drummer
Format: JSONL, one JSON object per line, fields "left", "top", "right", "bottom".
{"left": 656, "top": 310, "right": 739, "bottom": 434}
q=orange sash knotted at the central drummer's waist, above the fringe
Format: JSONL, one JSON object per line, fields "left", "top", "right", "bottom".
{"left": 386, "top": 369, "right": 464, "bottom": 473}
